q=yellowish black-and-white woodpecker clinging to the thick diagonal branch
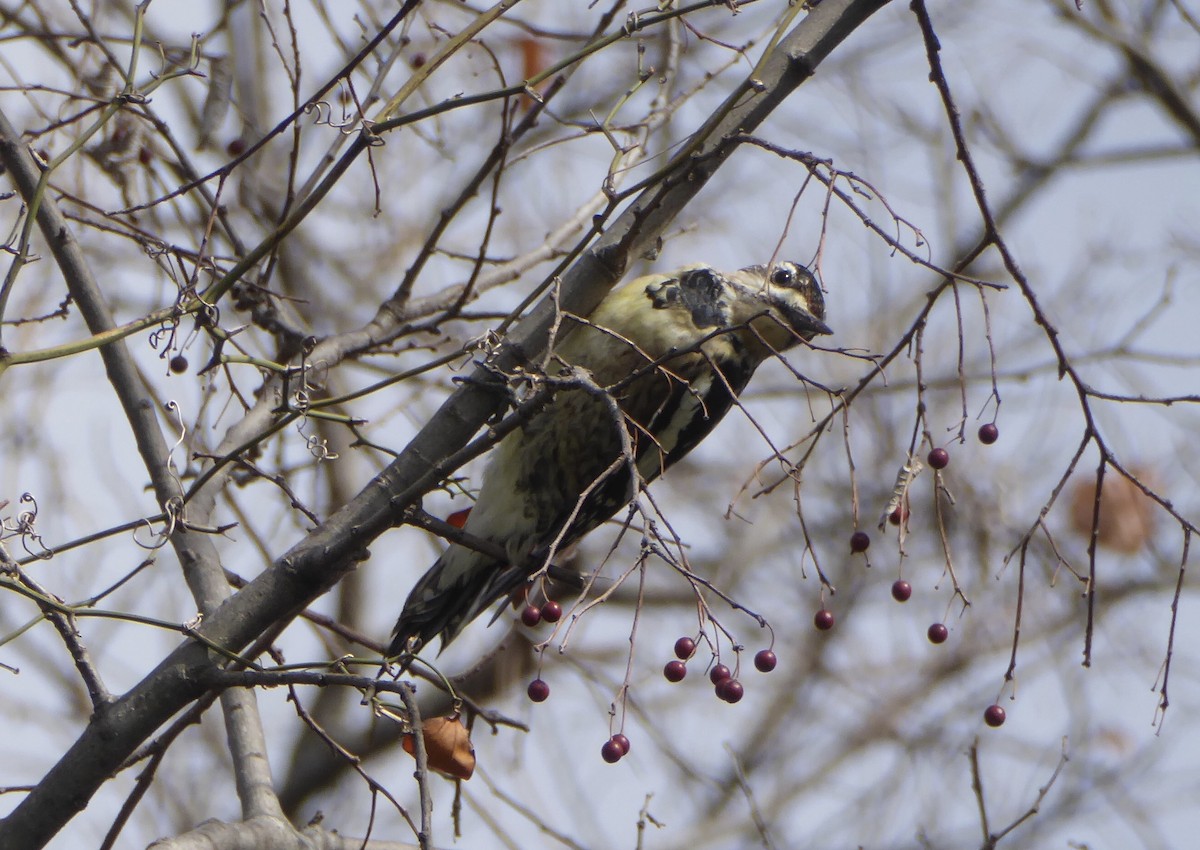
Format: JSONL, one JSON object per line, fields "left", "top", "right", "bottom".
{"left": 386, "top": 262, "right": 833, "bottom": 666}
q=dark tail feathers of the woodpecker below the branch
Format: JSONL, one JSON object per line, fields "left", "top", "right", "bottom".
{"left": 388, "top": 546, "right": 523, "bottom": 666}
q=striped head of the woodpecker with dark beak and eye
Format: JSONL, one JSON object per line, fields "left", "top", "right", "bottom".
{"left": 726, "top": 261, "right": 833, "bottom": 351}
